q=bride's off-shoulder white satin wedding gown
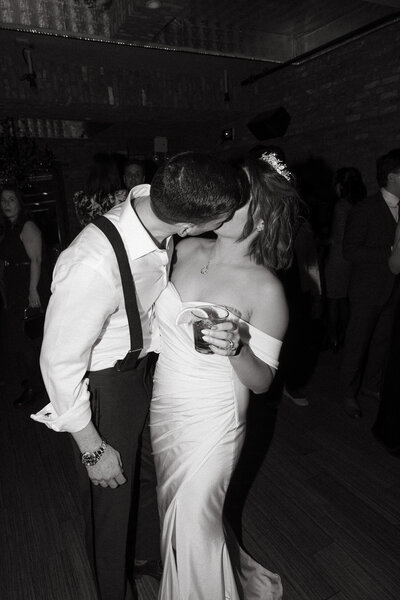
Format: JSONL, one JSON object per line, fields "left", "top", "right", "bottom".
{"left": 150, "top": 283, "right": 282, "bottom": 600}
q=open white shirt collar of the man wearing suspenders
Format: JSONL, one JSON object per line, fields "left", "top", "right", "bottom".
{"left": 119, "top": 183, "right": 171, "bottom": 260}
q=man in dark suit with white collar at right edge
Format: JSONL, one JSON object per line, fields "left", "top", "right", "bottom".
{"left": 342, "top": 148, "right": 400, "bottom": 418}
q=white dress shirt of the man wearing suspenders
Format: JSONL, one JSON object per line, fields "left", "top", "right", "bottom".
{"left": 31, "top": 184, "right": 173, "bottom": 432}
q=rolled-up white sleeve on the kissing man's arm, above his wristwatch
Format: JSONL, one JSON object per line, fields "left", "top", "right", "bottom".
{"left": 31, "top": 262, "right": 118, "bottom": 433}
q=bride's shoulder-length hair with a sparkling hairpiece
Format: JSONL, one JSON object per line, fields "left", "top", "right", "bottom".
{"left": 239, "top": 155, "right": 301, "bottom": 271}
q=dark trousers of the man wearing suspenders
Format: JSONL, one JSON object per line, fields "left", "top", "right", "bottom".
{"left": 72, "top": 355, "right": 160, "bottom": 600}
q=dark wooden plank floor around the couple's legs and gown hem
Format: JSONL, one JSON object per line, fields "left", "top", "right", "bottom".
{"left": 0, "top": 352, "right": 400, "bottom": 600}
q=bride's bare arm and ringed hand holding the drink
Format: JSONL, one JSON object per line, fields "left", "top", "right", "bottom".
{"left": 204, "top": 278, "right": 288, "bottom": 394}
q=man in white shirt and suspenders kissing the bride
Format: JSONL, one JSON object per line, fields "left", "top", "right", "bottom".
{"left": 33, "top": 153, "right": 246, "bottom": 600}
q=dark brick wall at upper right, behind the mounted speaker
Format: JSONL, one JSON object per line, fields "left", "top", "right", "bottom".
{"left": 231, "top": 24, "right": 400, "bottom": 192}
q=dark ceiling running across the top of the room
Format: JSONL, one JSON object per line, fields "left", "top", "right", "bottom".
{"left": 0, "top": 0, "right": 400, "bottom": 64}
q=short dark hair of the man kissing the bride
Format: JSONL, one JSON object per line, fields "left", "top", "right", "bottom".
{"left": 150, "top": 152, "right": 249, "bottom": 224}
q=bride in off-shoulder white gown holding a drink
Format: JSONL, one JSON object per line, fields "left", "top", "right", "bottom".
{"left": 150, "top": 154, "right": 299, "bottom": 600}
